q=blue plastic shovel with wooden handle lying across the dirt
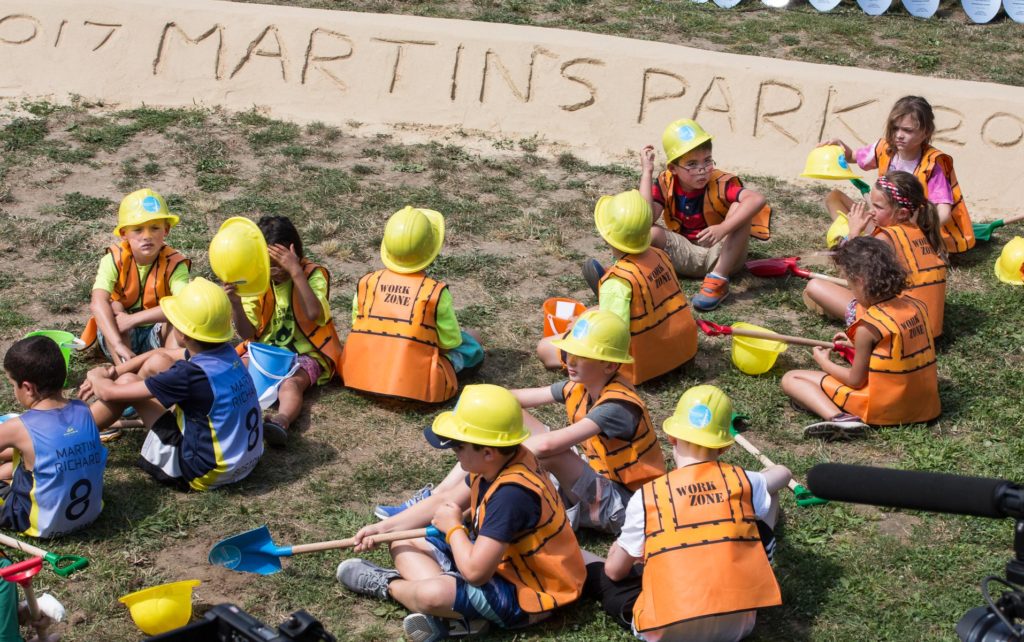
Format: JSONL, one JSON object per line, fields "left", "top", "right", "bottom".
{"left": 209, "top": 525, "right": 443, "bottom": 575}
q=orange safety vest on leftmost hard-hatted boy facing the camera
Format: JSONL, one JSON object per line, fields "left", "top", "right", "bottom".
{"left": 82, "top": 241, "right": 191, "bottom": 347}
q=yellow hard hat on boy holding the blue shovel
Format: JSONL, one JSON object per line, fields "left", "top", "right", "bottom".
{"left": 423, "top": 383, "right": 529, "bottom": 448}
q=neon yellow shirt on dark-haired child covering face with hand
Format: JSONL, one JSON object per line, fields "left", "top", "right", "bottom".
{"left": 242, "top": 270, "right": 331, "bottom": 386}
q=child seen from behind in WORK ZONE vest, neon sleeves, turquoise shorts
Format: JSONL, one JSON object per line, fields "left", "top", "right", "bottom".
{"left": 342, "top": 206, "right": 483, "bottom": 403}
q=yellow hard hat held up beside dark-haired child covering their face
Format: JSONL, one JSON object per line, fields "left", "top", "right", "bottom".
{"left": 210, "top": 216, "right": 270, "bottom": 297}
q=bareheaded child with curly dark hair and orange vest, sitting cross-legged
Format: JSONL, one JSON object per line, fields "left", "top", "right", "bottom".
{"left": 782, "top": 237, "right": 942, "bottom": 438}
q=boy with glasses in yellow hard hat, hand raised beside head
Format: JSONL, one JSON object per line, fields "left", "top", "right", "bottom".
{"left": 630, "top": 119, "right": 771, "bottom": 311}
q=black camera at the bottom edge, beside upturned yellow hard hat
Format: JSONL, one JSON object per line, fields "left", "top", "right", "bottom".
{"left": 145, "top": 604, "right": 337, "bottom": 642}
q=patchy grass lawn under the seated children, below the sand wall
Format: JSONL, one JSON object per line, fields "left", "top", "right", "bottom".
{"left": 0, "top": 93, "right": 1024, "bottom": 641}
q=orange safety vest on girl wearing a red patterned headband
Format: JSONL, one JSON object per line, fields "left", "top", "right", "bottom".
{"left": 873, "top": 223, "right": 946, "bottom": 338}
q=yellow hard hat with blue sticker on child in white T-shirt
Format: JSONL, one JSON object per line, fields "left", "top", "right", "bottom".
{"left": 662, "top": 385, "right": 735, "bottom": 448}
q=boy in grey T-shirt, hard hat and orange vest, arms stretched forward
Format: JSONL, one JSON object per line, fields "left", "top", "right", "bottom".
{"left": 374, "top": 309, "right": 665, "bottom": 533}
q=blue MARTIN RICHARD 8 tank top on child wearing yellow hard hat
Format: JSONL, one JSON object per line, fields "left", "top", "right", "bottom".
{"left": 183, "top": 344, "right": 263, "bottom": 490}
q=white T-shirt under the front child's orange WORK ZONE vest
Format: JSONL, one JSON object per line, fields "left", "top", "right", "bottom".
{"left": 615, "top": 471, "right": 771, "bottom": 642}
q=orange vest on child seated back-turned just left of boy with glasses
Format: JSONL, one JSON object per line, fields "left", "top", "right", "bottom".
{"left": 600, "top": 248, "right": 697, "bottom": 385}
